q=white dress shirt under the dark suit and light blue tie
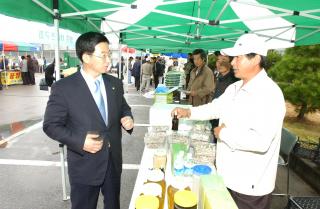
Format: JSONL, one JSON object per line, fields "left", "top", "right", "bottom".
{"left": 80, "top": 69, "right": 108, "bottom": 125}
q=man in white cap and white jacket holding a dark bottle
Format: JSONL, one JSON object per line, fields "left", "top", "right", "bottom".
{"left": 173, "top": 34, "right": 285, "bottom": 209}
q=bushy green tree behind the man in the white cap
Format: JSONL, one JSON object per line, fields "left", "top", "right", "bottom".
{"left": 269, "top": 45, "right": 320, "bottom": 119}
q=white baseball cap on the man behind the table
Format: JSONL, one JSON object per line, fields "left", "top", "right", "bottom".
{"left": 221, "top": 33, "right": 268, "bottom": 56}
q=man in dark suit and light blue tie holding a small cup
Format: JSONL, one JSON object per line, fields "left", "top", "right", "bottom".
{"left": 43, "top": 32, "right": 133, "bottom": 209}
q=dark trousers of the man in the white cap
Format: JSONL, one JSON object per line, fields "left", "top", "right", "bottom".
{"left": 228, "top": 189, "right": 272, "bottom": 209}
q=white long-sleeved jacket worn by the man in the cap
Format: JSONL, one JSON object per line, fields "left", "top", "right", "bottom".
{"left": 190, "top": 70, "right": 286, "bottom": 196}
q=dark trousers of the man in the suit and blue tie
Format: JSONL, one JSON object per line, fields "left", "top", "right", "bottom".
{"left": 71, "top": 158, "right": 121, "bottom": 209}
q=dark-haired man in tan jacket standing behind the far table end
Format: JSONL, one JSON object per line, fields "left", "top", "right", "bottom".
{"left": 187, "top": 49, "right": 215, "bottom": 106}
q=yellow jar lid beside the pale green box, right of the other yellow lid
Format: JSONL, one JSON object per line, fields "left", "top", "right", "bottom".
{"left": 174, "top": 190, "right": 198, "bottom": 208}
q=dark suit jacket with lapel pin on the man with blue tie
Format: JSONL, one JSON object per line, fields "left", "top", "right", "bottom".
{"left": 43, "top": 72, "right": 132, "bottom": 185}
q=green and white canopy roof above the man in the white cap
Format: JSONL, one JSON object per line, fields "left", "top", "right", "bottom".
{"left": 99, "top": 0, "right": 320, "bottom": 52}
